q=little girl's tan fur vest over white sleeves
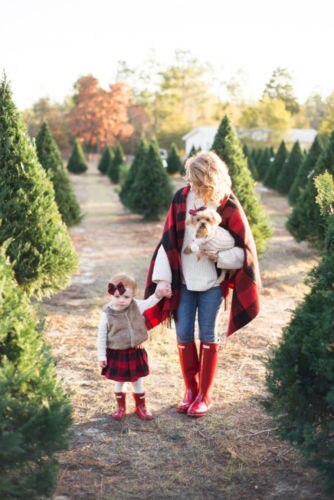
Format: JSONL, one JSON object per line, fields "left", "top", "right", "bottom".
{"left": 103, "top": 301, "right": 148, "bottom": 349}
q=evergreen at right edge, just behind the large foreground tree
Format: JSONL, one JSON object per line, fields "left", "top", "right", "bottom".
{"left": 286, "top": 132, "right": 334, "bottom": 246}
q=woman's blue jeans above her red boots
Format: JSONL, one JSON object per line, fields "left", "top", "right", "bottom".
{"left": 176, "top": 285, "right": 223, "bottom": 342}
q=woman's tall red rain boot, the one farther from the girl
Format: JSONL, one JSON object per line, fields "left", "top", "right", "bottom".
{"left": 187, "top": 342, "right": 219, "bottom": 417}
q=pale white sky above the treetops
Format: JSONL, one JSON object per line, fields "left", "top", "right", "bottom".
{"left": 0, "top": 0, "right": 334, "bottom": 109}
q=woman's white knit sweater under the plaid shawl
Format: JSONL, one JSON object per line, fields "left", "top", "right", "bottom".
{"left": 152, "top": 191, "right": 245, "bottom": 292}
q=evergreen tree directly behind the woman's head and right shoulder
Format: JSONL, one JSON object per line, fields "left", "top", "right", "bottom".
{"left": 212, "top": 116, "right": 271, "bottom": 254}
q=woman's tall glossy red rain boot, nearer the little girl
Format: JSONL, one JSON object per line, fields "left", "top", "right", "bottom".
{"left": 176, "top": 341, "right": 199, "bottom": 413}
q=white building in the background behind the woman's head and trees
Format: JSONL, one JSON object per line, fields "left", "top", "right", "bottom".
{"left": 182, "top": 126, "right": 317, "bottom": 152}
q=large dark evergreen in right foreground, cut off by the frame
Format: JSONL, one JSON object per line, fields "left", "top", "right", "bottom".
{"left": 263, "top": 173, "right": 334, "bottom": 492}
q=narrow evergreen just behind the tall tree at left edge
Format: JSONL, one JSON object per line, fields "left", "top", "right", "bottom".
{"left": 36, "top": 122, "right": 81, "bottom": 226}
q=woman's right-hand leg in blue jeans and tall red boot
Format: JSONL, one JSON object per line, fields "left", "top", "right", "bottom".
{"left": 187, "top": 287, "right": 222, "bottom": 417}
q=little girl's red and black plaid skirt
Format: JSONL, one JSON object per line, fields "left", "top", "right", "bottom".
{"left": 101, "top": 347, "right": 149, "bottom": 382}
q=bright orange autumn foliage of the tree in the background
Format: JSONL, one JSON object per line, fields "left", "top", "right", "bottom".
{"left": 69, "top": 75, "right": 133, "bottom": 151}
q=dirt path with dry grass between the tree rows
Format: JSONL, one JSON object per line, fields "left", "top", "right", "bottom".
{"left": 45, "top": 165, "right": 325, "bottom": 499}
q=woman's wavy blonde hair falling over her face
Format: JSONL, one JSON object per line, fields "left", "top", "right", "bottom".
{"left": 184, "top": 151, "right": 232, "bottom": 203}
